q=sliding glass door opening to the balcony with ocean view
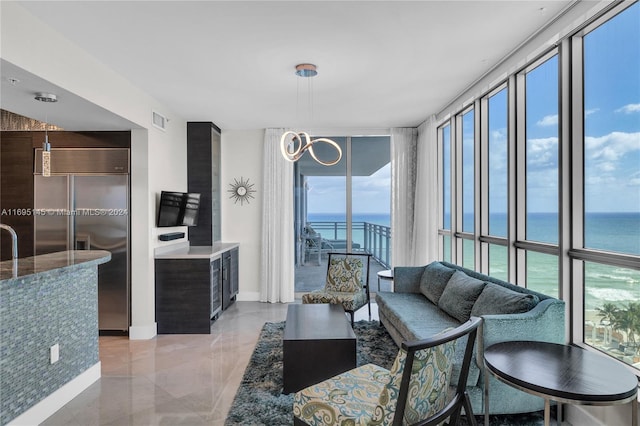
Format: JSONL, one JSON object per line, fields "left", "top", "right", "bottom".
{"left": 295, "top": 136, "right": 391, "bottom": 292}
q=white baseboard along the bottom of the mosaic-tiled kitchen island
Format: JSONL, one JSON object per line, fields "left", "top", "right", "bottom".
{"left": 8, "top": 362, "right": 101, "bottom": 426}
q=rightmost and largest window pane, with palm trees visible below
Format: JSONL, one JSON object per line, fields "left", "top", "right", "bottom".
{"left": 574, "top": 3, "right": 640, "bottom": 367}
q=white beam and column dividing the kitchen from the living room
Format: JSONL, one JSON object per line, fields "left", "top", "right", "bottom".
{"left": 0, "top": 2, "right": 187, "bottom": 338}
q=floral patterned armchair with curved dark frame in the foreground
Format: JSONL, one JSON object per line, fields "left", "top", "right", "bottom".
{"left": 293, "top": 317, "right": 482, "bottom": 426}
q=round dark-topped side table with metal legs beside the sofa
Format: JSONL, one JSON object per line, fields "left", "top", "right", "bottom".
{"left": 484, "top": 341, "right": 638, "bottom": 426}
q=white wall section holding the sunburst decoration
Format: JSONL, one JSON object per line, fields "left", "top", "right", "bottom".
{"left": 221, "top": 129, "right": 264, "bottom": 300}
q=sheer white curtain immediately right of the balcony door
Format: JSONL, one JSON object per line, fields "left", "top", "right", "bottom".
{"left": 391, "top": 128, "right": 418, "bottom": 266}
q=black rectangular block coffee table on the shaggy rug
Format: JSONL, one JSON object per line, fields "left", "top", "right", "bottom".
{"left": 282, "top": 304, "right": 356, "bottom": 394}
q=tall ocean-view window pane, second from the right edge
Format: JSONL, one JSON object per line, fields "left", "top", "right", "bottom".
{"left": 516, "top": 51, "right": 559, "bottom": 297}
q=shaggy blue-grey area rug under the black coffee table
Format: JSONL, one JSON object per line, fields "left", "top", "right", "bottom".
{"left": 225, "top": 321, "right": 553, "bottom": 426}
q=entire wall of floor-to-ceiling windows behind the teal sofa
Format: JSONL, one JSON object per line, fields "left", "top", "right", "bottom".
{"left": 438, "top": 2, "right": 640, "bottom": 375}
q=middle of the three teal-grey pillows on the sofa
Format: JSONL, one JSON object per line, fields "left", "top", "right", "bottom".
{"left": 438, "top": 271, "right": 486, "bottom": 322}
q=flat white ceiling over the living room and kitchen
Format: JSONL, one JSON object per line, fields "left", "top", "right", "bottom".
{"left": 1, "top": 0, "right": 573, "bottom": 130}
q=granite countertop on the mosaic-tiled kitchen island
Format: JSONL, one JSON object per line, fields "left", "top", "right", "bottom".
{"left": 0, "top": 250, "right": 111, "bottom": 281}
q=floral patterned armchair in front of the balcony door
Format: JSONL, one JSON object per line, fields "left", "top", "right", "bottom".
{"left": 302, "top": 253, "right": 371, "bottom": 325}
